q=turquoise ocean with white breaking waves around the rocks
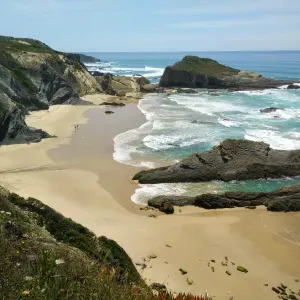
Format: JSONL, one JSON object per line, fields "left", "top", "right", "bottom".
{"left": 86, "top": 51, "right": 300, "bottom": 204}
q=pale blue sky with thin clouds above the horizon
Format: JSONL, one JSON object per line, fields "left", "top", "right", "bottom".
{"left": 0, "top": 0, "right": 300, "bottom": 52}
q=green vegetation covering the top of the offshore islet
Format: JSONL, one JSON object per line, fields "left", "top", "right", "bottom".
{"left": 172, "top": 56, "right": 239, "bottom": 77}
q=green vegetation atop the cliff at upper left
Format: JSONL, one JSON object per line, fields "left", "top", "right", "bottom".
{"left": 0, "top": 36, "right": 54, "bottom": 53}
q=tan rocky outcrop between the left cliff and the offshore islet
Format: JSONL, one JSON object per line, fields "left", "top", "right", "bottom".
{"left": 95, "top": 74, "right": 153, "bottom": 97}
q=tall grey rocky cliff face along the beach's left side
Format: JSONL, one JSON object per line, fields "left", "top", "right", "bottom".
{"left": 0, "top": 36, "right": 102, "bottom": 143}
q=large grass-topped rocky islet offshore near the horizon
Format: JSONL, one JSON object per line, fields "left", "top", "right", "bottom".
{"left": 159, "top": 56, "right": 293, "bottom": 90}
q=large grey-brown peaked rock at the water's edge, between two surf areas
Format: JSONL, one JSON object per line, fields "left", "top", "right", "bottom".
{"left": 134, "top": 139, "right": 300, "bottom": 183}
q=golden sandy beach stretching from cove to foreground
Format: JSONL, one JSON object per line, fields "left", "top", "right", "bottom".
{"left": 0, "top": 95, "right": 300, "bottom": 300}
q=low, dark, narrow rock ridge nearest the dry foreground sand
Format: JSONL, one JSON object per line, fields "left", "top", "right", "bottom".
{"left": 148, "top": 184, "right": 300, "bottom": 212}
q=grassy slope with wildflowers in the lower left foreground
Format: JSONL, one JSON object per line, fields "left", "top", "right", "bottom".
{"left": 0, "top": 187, "right": 212, "bottom": 300}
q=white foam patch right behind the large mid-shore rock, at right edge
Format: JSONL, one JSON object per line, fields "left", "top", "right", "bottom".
{"left": 245, "top": 130, "right": 300, "bottom": 150}
